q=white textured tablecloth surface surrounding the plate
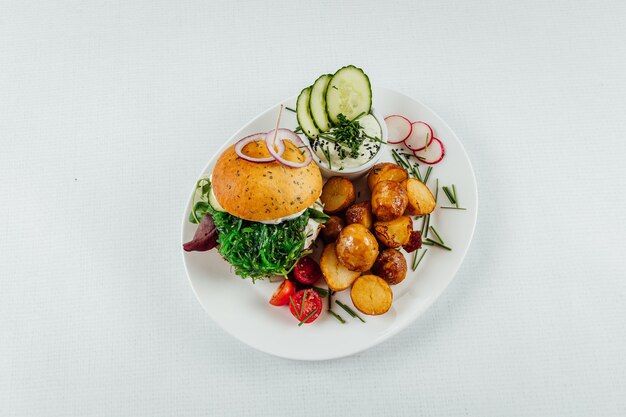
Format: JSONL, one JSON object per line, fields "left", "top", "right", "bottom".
{"left": 0, "top": 0, "right": 626, "bottom": 416}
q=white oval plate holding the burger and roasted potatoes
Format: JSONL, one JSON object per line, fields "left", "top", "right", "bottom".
{"left": 182, "top": 89, "right": 478, "bottom": 360}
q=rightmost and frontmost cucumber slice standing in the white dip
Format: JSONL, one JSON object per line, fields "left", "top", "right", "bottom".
{"left": 326, "top": 65, "right": 372, "bottom": 124}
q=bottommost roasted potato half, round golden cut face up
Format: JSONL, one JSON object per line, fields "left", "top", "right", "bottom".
{"left": 350, "top": 275, "right": 393, "bottom": 316}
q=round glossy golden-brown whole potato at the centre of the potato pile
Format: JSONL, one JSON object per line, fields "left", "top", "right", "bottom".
{"left": 335, "top": 223, "right": 378, "bottom": 272}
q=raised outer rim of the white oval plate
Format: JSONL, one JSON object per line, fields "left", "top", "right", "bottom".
{"left": 180, "top": 87, "right": 479, "bottom": 361}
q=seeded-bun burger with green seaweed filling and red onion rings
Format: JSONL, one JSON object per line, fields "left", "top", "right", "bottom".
{"left": 183, "top": 129, "right": 328, "bottom": 280}
